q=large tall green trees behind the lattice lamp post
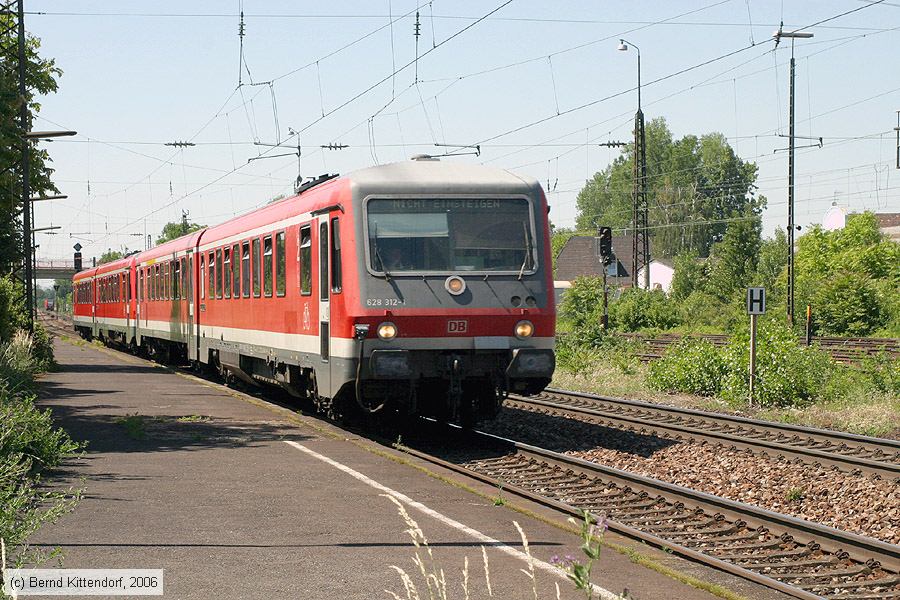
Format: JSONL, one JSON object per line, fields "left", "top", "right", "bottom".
{"left": 576, "top": 117, "right": 764, "bottom": 256}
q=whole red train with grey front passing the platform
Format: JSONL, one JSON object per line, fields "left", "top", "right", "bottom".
{"left": 74, "top": 158, "right": 556, "bottom": 422}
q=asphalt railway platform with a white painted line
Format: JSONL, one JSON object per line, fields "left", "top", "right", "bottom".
{"left": 33, "top": 338, "right": 783, "bottom": 599}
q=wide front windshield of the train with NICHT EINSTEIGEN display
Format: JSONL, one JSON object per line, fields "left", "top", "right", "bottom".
{"left": 366, "top": 198, "right": 535, "bottom": 274}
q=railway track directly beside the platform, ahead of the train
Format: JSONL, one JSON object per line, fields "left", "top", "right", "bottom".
{"left": 404, "top": 431, "right": 900, "bottom": 600}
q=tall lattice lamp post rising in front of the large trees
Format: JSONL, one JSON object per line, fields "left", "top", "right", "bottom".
{"left": 617, "top": 39, "right": 650, "bottom": 290}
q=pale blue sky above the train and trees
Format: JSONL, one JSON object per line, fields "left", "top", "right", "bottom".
{"left": 26, "top": 0, "right": 900, "bottom": 268}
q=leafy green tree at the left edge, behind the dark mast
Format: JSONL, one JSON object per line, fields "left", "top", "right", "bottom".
{"left": 0, "top": 13, "right": 62, "bottom": 273}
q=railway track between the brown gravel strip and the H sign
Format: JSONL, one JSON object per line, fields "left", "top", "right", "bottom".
{"left": 506, "top": 389, "right": 900, "bottom": 483}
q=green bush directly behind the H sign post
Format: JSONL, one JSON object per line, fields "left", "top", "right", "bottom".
{"left": 721, "top": 320, "right": 839, "bottom": 406}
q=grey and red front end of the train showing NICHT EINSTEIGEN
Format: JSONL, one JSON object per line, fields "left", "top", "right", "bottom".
{"left": 352, "top": 159, "right": 556, "bottom": 424}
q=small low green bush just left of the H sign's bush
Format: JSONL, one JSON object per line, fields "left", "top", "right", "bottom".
{"left": 648, "top": 338, "right": 725, "bottom": 396}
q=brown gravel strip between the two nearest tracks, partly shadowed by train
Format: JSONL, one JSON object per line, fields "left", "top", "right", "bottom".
{"left": 482, "top": 407, "right": 900, "bottom": 544}
